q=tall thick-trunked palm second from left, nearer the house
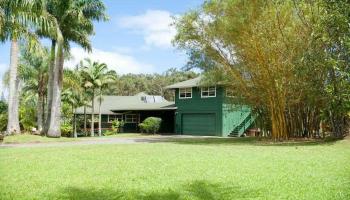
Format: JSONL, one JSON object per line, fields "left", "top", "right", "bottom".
{"left": 47, "top": 0, "right": 107, "bottom": 137}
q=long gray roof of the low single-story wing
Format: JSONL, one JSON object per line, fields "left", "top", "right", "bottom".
{"left": 75, "top": 93, "right": 176, "bottom": 114}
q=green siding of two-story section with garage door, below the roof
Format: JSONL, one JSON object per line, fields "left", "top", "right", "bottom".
{"left": 175, "top": 87, "right": 251, "bottom": 137}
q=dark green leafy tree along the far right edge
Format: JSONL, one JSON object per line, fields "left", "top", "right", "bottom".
{"left": 313, "top": 0, "right": 350, "bottom": 138}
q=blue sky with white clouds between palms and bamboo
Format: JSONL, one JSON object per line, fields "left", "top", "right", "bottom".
{"left": 0, "top": 0, "right": 203, "bottom": 93}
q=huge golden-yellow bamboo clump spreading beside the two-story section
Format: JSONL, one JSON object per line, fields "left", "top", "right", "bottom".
{"left": 174, "top": 0, "right": 321, "bottom": 139}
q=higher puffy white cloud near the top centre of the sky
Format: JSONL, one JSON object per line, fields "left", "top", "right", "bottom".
{"left": 118, "top": 10, "right": 176, "bottom": 48}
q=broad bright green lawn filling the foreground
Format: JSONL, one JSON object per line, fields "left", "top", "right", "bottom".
{"left": 0, "top": 139, "right": 350, "bottom": 200}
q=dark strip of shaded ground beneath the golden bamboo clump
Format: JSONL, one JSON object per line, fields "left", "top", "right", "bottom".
{"left": 162, "top": 137, "right": 336, "bottom": 147}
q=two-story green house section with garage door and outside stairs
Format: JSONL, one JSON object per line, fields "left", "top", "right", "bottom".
{"left": 166, "top": 77, "right": 254, "bottom": 137}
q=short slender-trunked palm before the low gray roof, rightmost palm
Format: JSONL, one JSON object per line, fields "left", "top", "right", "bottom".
{"left": 82, "top": 59, "right": 110, "bottom": 136}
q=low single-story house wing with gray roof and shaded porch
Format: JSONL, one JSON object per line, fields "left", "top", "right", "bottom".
{"left": 75, "top": 92, "right": 176, "bottom": 134}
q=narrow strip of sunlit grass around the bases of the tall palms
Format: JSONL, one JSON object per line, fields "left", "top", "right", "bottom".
{"left": 3, "top": 133, "right": 150, "bottom": 144}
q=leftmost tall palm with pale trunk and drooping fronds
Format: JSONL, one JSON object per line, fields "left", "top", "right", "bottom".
{"left": 0, "top": 0, "right": 54, "bottom": 134}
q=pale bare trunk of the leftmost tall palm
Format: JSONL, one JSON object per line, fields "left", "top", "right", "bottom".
{"left": 6, "top": 39, "right": 21, "bottom": 135}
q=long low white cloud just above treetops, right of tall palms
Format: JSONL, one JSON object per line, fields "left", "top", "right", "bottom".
{"left": 65, "top": 47, "right": 155, "bottom": 74}
